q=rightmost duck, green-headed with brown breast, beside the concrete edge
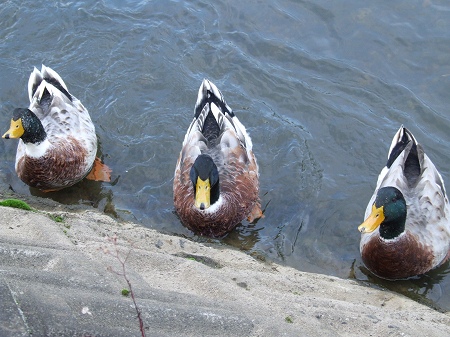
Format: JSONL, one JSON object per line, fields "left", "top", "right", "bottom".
{"left": 358, "top": 126, "right": 450, "bottom": 279}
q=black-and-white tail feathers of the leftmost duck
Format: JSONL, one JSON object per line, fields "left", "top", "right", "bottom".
{"left": 28, "top": 65, "right": 73, "bottom": 102}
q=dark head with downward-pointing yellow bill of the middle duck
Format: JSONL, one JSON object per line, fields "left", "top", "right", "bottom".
{"left": 190, "top": 154, "right": 219, "bottom": 210}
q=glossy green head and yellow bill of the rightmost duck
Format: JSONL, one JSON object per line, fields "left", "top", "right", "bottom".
{"left": 358, "top": 186, "right": 406, "bottom": 239}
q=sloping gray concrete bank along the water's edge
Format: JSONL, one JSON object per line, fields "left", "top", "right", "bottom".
{"left": 0, "top": 193, "right": 450, "bottom": 337}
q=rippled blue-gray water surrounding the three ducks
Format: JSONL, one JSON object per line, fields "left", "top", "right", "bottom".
{"left": 0, "top": 0, "right": 450, "bottom": 310}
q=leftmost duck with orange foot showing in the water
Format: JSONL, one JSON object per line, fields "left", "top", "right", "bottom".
{"left": 3, "top": 65, "right": 110, "bottom": 191}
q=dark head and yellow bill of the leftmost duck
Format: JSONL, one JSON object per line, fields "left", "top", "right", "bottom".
{"left": 2, "top": 108, "right": 47, "bottom": 144}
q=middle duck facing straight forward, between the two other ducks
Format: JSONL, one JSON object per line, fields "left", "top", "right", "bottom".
{"left": 173, "top": 79, "right": 262, "bottom": 237}
